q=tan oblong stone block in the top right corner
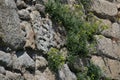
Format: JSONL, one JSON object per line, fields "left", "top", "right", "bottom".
{"left": 92, "top": 0, "right": 118, "bottom": 16}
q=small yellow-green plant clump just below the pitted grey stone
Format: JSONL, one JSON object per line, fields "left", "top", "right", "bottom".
{"left": 48, "top": 48, "right": 65, "bottom": 71}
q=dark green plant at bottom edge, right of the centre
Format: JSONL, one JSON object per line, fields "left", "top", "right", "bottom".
{"left": 77, "top": 63, "right": 102, "bottom": 80}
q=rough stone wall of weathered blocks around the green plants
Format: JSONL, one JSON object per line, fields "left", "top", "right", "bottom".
{"left": 0, "top": 0, "right": 120, "bottom": 80}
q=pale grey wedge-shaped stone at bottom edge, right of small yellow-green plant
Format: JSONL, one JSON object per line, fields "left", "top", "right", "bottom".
{"left": 59, "top": 64, "right": 77, "bottom": 80}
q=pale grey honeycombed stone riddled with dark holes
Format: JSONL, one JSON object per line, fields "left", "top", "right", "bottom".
{"left": 30, "top": 11, "right": 53, "bottom": 51}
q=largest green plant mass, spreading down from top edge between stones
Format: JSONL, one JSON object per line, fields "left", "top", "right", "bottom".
{"left": 46, "top": 0, "right": 99, "bottom": 56}
